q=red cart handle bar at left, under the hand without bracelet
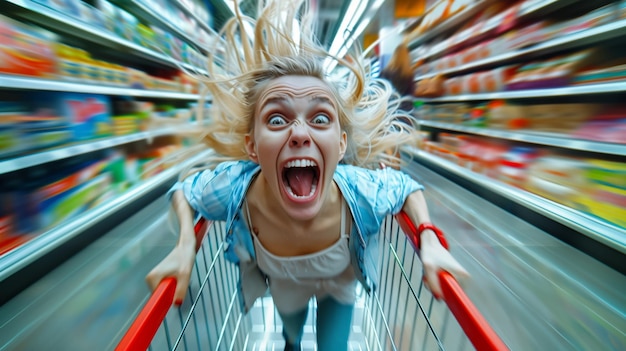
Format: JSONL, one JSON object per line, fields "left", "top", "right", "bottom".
{"left": 115, "top": 218, "right": 209, "bottom": 351}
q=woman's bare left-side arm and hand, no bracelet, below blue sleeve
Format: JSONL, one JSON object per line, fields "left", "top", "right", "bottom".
{"left": 146, "top": 190, "right": 196, "bottom": 305}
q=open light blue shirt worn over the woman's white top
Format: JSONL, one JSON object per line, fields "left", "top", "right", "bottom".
{"left": 169, "top": 161, "right": 424, "bottom": 311}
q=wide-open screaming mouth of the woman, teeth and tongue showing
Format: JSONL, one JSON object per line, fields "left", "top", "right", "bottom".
{"left": 283, "top": 159, "right": 320, "bottom": 200}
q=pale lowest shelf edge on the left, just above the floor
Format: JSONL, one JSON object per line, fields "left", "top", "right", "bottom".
{"left": 0, "top": 151, "right": 211, "bottom": 281}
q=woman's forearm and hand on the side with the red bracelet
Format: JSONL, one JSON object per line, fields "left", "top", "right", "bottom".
{"left": 402, "top": 190, "right": 469, "bottom": 298}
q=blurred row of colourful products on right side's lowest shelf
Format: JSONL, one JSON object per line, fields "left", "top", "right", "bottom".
{"left": 423, "top": 133, "right": 626, "bottom": 229}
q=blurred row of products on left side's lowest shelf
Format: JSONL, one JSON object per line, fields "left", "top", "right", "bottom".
{"left": 0, "top": 138, "right": 182, "bottom": 254}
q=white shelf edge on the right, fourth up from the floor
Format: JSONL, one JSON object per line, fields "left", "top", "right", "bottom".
{"left": 415, "top": 19, "right": 626, "bottom": 81}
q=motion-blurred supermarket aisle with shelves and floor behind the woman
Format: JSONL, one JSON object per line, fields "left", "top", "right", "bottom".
{"left": 0, "top": 0, "right": 626, "bottom": 350}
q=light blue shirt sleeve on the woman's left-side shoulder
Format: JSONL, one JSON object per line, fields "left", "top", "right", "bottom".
{"left": 167, "top": 164, "right": 237, "bottom": 220}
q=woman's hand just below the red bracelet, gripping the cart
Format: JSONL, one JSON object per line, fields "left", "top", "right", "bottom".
{"left": 420, "top": 229, "right": 469, "bottom": 299}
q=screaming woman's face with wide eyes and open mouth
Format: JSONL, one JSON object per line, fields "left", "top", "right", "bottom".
{"left": 246, "top": 76, "right": 347, "bottom": 221}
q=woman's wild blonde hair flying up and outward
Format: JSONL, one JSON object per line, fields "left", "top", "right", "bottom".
{"left": 188, "top": 1, "right": 416, "bottom": 173}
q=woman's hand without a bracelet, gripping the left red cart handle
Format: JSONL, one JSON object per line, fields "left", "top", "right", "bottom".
{"left": 146, "top": 238, "right": 196, "bottom": 305}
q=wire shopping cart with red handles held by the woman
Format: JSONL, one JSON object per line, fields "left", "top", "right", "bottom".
{"left": 116, "top": 213, "right": 508, "bottom": 351}
